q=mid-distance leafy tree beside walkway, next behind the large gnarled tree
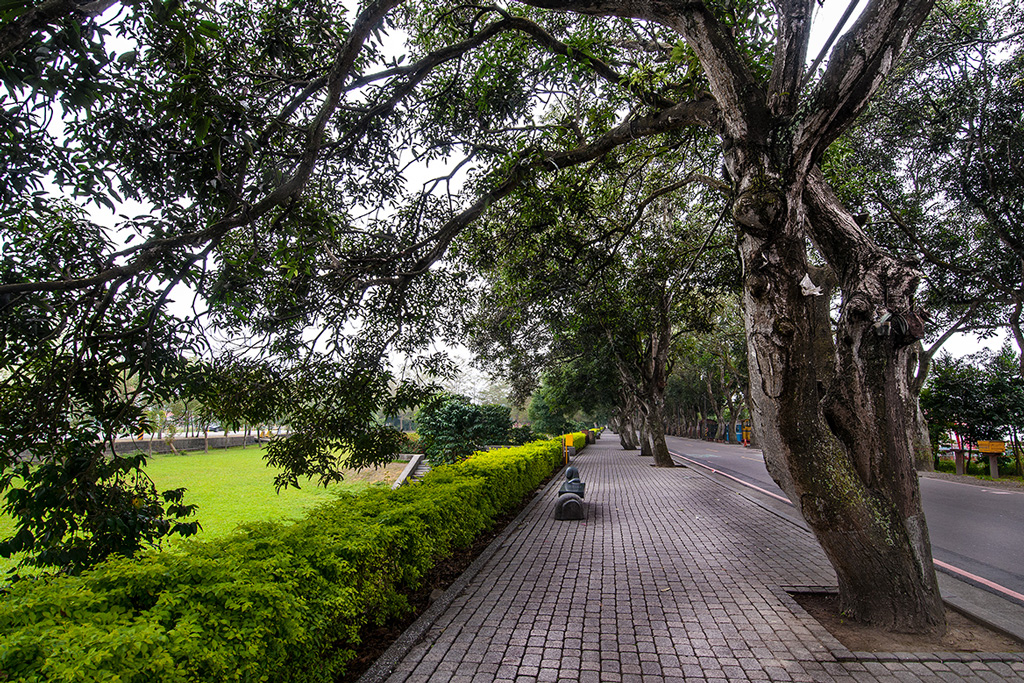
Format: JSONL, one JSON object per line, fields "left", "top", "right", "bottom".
{"left": 463, "top": 153, "right": 735, "bottom": 467}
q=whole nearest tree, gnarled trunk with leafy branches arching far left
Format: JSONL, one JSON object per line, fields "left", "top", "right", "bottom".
{"left": 0, "top": 0, "right": 966, "bottom": 631}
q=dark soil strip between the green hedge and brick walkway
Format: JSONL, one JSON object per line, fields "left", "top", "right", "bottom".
{"left": 336, "top": 469, "right": 561, "bottom": 683}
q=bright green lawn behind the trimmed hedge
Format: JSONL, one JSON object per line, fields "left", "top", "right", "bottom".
{"left": 0, "top": 445, "right": 404, "bottom": 572}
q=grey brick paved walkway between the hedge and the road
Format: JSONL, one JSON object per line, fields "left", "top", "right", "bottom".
{"left": 372, "top": 440, "right": 1024, "bottom": 683}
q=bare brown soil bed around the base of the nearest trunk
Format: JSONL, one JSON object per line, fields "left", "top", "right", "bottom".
{"left": 791, "top": 593, "right": 1024, "bottom": 652}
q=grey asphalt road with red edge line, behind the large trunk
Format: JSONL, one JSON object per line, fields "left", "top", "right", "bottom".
{"left": 668, "top": 436, "right": 1024, "bottom": 602}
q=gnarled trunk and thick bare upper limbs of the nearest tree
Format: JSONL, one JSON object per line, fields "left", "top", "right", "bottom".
{"left": 525, "top": 0, "right": 945, "bottom": 632}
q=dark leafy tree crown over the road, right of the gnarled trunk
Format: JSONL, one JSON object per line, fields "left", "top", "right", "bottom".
{"left": 826, "top": 0, "right": 1024, "bottom": 374}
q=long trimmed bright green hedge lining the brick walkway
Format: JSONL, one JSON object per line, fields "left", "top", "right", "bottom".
{"left": 0, "top": 439, "right": 565, "bottom": 683}
